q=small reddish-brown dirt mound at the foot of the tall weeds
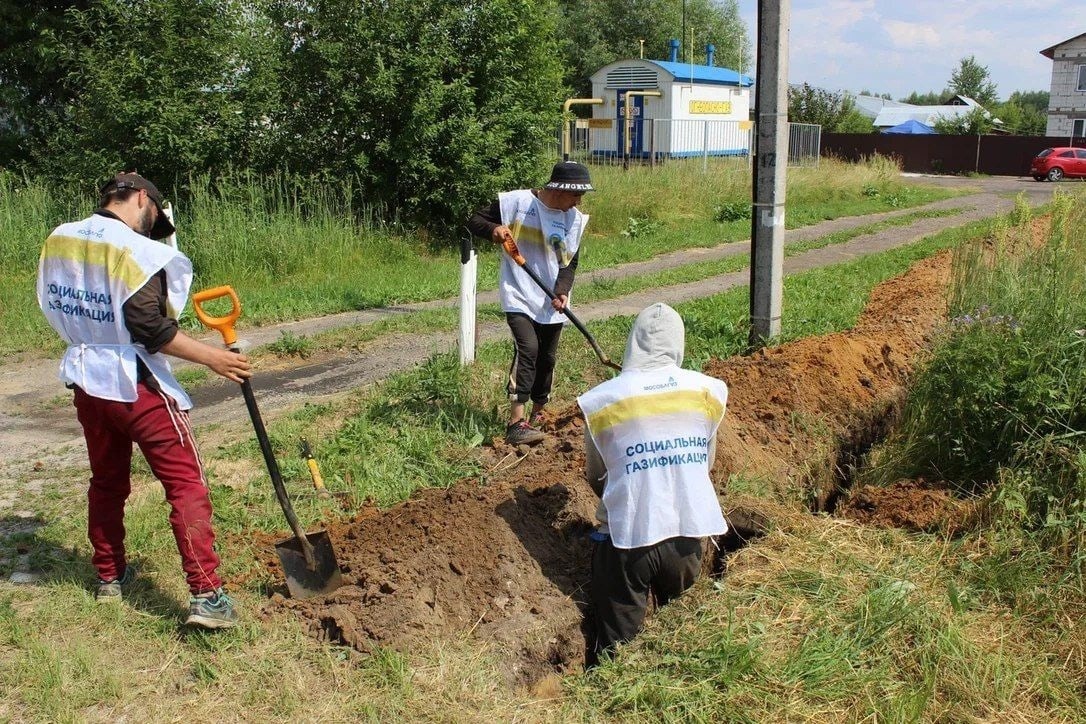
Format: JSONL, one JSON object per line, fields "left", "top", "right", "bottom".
{"left": 836, "top": 479, "right": 977, "bottom": 535}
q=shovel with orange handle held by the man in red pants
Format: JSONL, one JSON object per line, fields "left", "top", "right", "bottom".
{"left": 192, "top": 287, "right": 343, "bottom": 598}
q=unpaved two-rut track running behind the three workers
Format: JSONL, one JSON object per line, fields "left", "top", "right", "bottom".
{"left": 0, "top": 177, "right": 1064, "bottom": 490}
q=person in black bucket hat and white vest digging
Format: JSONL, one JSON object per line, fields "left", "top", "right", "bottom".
{"left": 467, "top": 161, "right": 593, "bottom": 445}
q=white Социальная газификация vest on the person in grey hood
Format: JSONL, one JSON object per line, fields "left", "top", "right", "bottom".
{"left": 577, "top": 366, "right": 728, "bottom": 548}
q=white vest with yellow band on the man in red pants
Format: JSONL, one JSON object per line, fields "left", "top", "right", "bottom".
{"left": 38, "top": 214, "right": 192, "bottom": 409}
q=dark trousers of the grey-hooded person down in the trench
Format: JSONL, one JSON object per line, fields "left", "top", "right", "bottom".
{"left": 592, "top": 538, "right": 703, "bottom": 656}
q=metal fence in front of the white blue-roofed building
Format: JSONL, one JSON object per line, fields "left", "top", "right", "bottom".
{"left": 555, "top": 118, "right": 822, "bottom": 167}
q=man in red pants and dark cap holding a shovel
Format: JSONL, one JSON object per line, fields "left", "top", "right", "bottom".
{"left": 37, "top": 174, "right": 250, "bottom": 628}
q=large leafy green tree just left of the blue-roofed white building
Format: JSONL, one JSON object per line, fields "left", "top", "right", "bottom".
{"left": 273, "top": 0, "right": 563, "bottom": 228}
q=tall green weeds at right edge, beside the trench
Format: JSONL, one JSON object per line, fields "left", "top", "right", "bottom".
{"left": 872, "top": 194, "right": 1086, "bottom": 549}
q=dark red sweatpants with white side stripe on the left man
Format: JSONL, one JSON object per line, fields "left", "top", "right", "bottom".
{"left": 75, "top": 382, "right": 222, "bottom": 593}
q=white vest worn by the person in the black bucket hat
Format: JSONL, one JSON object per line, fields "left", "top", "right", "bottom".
{"left": 497, "top": 189, "right": 589, "bottom": 325}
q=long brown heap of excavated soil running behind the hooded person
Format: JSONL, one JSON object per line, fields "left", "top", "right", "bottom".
{"left": 266, "top": 249, "right": 949, "bottom": 685}
